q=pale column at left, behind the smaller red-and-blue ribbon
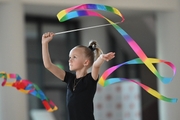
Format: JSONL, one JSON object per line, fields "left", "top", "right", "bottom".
{"left": 0, "top": 0, "right": 28, "bottom": 120}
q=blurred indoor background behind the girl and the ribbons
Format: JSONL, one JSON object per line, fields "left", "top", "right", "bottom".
{"left": 0, "top": 0, "right": 180, "bottom": 120}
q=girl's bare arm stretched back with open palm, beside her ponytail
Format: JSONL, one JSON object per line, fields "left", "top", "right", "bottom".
{"left": 91, "top": 52, "right": 115, "bottom": 80}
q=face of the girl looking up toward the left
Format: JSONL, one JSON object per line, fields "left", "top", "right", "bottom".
{"left": 69, "top": 48, "right": 86, "bottom": 71}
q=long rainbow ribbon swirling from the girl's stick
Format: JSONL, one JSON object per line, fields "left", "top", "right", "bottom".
{"left": 57, "top": 4, "right": 177, "bottom": 103}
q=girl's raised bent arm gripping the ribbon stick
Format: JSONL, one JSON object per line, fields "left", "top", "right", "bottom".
{"left": 42, "top": 32, "right": 65, "bottom": 80}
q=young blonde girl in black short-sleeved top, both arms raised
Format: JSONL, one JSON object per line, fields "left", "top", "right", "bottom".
{"left": 42, "top": 32, "right": 115, "bottom": 120}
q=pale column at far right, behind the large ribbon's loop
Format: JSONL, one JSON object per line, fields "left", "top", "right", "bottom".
{"left": 157, "top": 1, "right": 180, "bottom": 120}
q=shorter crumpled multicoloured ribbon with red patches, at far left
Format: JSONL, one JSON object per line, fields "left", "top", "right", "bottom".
{"left": 0, "top": 72, "right": 58, "bottom": 112}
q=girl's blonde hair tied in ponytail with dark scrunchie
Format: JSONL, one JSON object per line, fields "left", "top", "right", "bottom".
{"left": 76, "top": 40, "right": 103, "bottom": 66}
